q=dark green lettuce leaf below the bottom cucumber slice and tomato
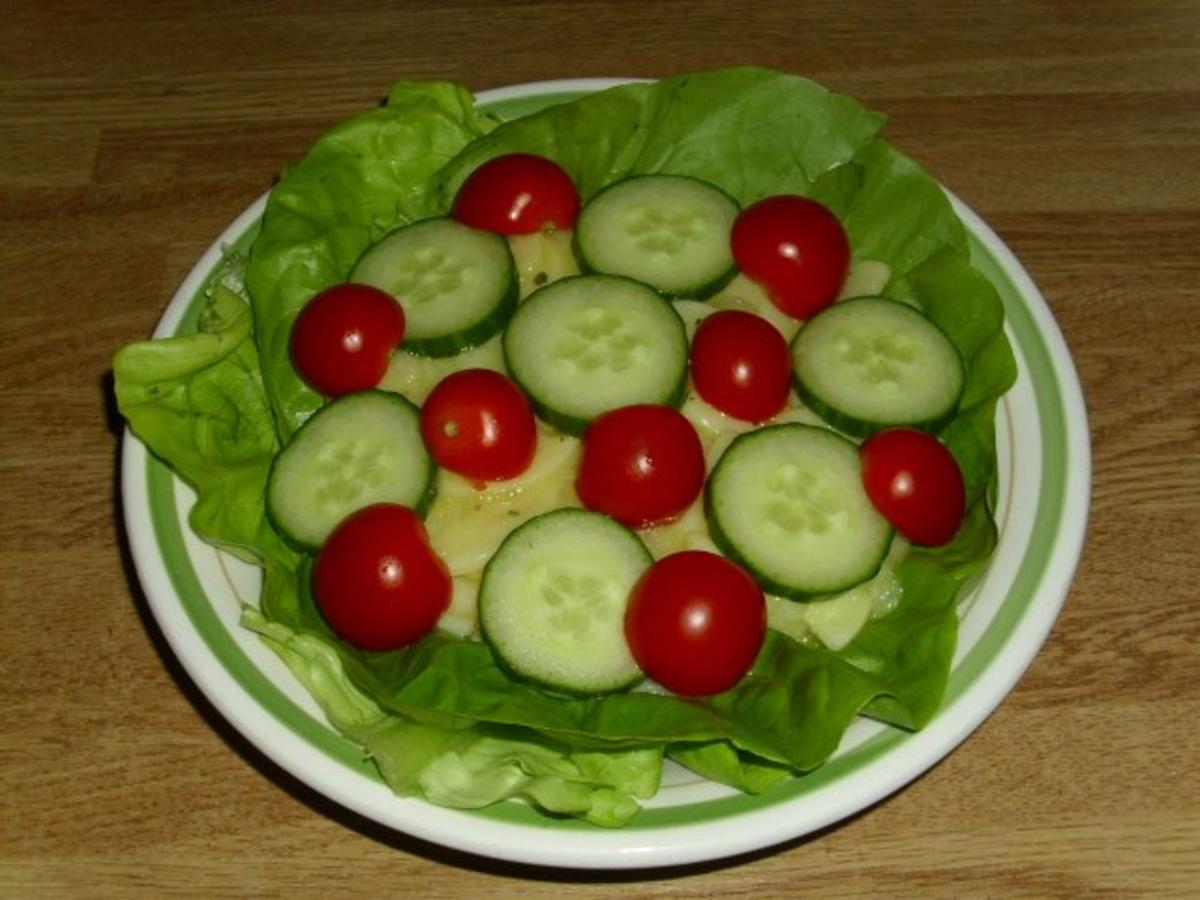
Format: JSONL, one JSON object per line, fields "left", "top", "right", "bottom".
{"left": 326, "top": 619, "right": 956, "bottom": 772}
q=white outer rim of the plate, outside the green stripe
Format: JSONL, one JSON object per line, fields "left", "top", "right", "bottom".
{"left": 121, "top": 78, "right": 1091, "bottom": 869}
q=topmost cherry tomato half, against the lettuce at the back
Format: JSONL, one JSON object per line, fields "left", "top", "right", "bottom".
{"left": 454, "top": 154, "right": 580, "bottom": 234}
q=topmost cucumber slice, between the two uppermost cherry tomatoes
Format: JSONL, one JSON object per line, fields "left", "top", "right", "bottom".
{"left": 575, "top": 175, "right": 740, "bottom": 298}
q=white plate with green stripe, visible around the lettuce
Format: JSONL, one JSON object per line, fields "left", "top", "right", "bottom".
{"left": 121, "top": 79, "right": 1091, "bottom": 869}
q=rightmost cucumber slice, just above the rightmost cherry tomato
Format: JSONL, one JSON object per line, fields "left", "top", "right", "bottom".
{"left": 792, "top": 296, "right": 966, "bottom": 437}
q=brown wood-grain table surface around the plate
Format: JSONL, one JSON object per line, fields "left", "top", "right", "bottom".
{"left": 0, "top": 0, "right": 1200, "bottom": 898}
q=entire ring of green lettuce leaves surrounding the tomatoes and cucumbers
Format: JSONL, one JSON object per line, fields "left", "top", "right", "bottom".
{"left": 114, "top": 67, "right": 1015, "bottom": 824}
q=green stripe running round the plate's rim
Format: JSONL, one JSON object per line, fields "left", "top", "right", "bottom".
{"left": 146, "top": 91, "right": 1068, "bottom": 830}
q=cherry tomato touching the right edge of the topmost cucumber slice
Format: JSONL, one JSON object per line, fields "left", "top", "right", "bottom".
{"left": 731, "top": 194, "right": 850, "bottom": 319}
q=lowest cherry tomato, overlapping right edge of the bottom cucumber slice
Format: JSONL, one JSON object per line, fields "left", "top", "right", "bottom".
{"left": 625, "top": 550, "right": 767, "bottom": 697}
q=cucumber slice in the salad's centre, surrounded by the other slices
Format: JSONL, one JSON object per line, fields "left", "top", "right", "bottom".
{"left": 504, "top": 275, "right": 688, "bottom": 436}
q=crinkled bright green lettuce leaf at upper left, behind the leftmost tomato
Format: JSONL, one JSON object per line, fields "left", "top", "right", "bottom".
{"left": 246, "top": 82, "right": 496, "bottom": 440}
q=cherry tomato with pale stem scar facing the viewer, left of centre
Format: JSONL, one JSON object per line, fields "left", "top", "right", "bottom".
{"left": 421, "top": 368, "right": 538, "bottom": 481}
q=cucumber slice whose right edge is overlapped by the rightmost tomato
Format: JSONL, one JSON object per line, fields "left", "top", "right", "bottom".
{"left": 704, "top": 425, "right": 892, "bottom": 600}
